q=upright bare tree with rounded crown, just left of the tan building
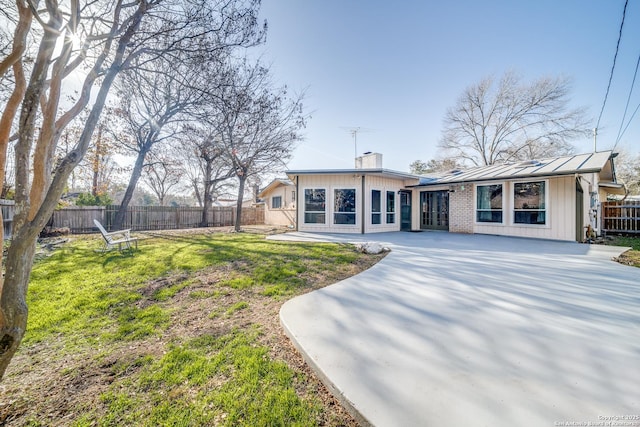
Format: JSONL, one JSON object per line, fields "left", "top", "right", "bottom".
{"left": 212, "top": 62, "right": 306, "bottom": 231}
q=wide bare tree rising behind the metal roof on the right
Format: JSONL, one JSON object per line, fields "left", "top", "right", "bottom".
{"left": 440, "top": 72, "right": 587, "bottom": 166}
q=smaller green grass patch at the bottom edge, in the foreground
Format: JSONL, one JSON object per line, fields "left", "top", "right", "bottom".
{"left": 96, "top": 330, "right": 320, "bottom": 426}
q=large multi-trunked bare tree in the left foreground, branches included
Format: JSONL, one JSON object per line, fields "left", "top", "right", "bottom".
{"left": 0, "top": 0, "right": 260, "bottom": 378}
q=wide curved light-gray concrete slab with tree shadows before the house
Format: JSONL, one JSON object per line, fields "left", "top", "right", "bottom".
{"left": 273, "top": 232, "right": 640, "bottom": 427}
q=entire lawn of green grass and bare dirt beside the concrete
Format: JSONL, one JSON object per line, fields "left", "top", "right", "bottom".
{"left": 0, "top": 233, "right": 380, "bottom": 426}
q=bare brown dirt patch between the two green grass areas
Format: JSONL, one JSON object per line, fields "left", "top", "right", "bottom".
{"left": 0, "top": 236, "right": 384, "bottom": 426}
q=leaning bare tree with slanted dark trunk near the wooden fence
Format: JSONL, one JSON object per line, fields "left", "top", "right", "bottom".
{"left": 113, "top": 34, "right": 259, "bottom": 229}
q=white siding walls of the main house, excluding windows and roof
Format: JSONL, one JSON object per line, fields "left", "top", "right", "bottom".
{"left": 292, "top": 174, "right": 597, "bottom": 241}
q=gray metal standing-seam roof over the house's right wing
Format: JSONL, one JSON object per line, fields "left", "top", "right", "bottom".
{"left": 420, "top": 151, "right": 615, "bottom": 185}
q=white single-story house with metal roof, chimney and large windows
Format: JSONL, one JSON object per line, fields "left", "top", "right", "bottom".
{"left": 287, "top": 151, "right": 624, "bottom": 241}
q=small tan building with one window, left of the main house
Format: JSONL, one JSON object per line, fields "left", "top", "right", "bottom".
{"left": 258, "top": 179, "right": 296, "bottom": 227}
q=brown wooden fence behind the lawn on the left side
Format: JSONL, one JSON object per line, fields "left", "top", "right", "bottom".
{"left": 0, "top": 199, "right": 264, "bottom": 239}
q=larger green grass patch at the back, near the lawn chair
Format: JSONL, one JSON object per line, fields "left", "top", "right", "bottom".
{"left": 24, "top": 234, "right": 359, "bottom": 345}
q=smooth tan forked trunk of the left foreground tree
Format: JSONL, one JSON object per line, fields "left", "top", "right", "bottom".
{"left": 0, "top": 3, "right": 146, "bottom": 380}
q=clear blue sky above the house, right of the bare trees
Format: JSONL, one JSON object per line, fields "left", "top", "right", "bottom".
{"left": 255, "top": 0, "right": 640, "bottom": 170}
